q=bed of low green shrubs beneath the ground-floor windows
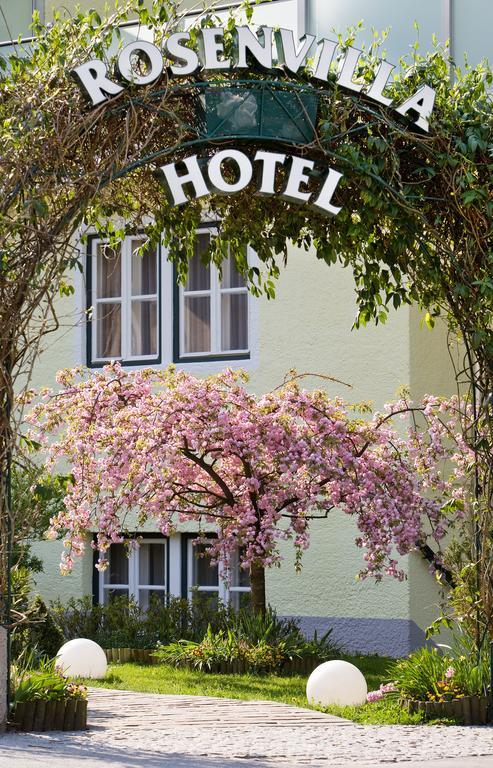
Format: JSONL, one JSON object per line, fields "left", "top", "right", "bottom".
{"left": 35, "top": 594, "right": 341, "bottom": 672}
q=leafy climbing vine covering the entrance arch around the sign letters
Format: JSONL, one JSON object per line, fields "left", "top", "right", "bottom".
{"left": 0, "top": 0, "right": 493, "bottom": 640}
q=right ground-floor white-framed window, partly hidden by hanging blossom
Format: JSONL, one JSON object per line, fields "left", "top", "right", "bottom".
{"left": 187, "top": 539, "right": 251, "bottom": 610}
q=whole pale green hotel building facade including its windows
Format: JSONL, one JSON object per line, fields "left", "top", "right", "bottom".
{"left": 0, "top": 0, "right": 493, "bottom": 656}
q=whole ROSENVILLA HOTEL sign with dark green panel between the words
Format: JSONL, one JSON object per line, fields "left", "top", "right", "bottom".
{"left": 71, "top": 16, "right": 435, "bottom": 215}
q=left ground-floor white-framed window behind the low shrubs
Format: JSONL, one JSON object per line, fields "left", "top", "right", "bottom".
{"left": 99, "top": 538, "right": 168, "bottom": 608}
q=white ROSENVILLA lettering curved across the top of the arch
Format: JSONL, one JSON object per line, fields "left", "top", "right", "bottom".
{"left": 72, "top": 26, "right": 435, "bottom": 131}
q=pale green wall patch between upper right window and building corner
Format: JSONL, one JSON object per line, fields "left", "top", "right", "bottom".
{"left": 252, "top": 248, "right": 409, "bottom": 407}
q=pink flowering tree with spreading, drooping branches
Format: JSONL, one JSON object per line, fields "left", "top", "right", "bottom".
{"left": 30, "top": 364, "right": 471, "bottom": 611}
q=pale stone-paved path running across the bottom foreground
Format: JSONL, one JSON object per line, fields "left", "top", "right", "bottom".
{"left": 0, "top": 689, "right": 493, "bottom": 768}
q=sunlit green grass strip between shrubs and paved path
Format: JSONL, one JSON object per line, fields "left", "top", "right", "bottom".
{"left": 87, "top": 656, "right": 428, "bottom": 725}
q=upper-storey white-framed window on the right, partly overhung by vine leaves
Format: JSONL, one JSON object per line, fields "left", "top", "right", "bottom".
{"left": 175, "top": 227, "right": 250, "bottom": 360}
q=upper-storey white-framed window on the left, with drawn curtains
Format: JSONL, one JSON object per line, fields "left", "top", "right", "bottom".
{"left": 89, "top": 236, "right": 160, "bottom": 364}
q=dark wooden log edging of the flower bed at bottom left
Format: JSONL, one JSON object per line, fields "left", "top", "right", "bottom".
{"left": 9, "top": 699, "right": 87, "bottom": 732}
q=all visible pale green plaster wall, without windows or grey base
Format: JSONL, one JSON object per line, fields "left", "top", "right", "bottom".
{"left": 26, "top": 248, "right": 454, "bottom": 640}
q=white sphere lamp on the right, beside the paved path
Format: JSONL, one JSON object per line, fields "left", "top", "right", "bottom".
{"left": 306, "top": 660, "right": 368, "bottom": 707}
